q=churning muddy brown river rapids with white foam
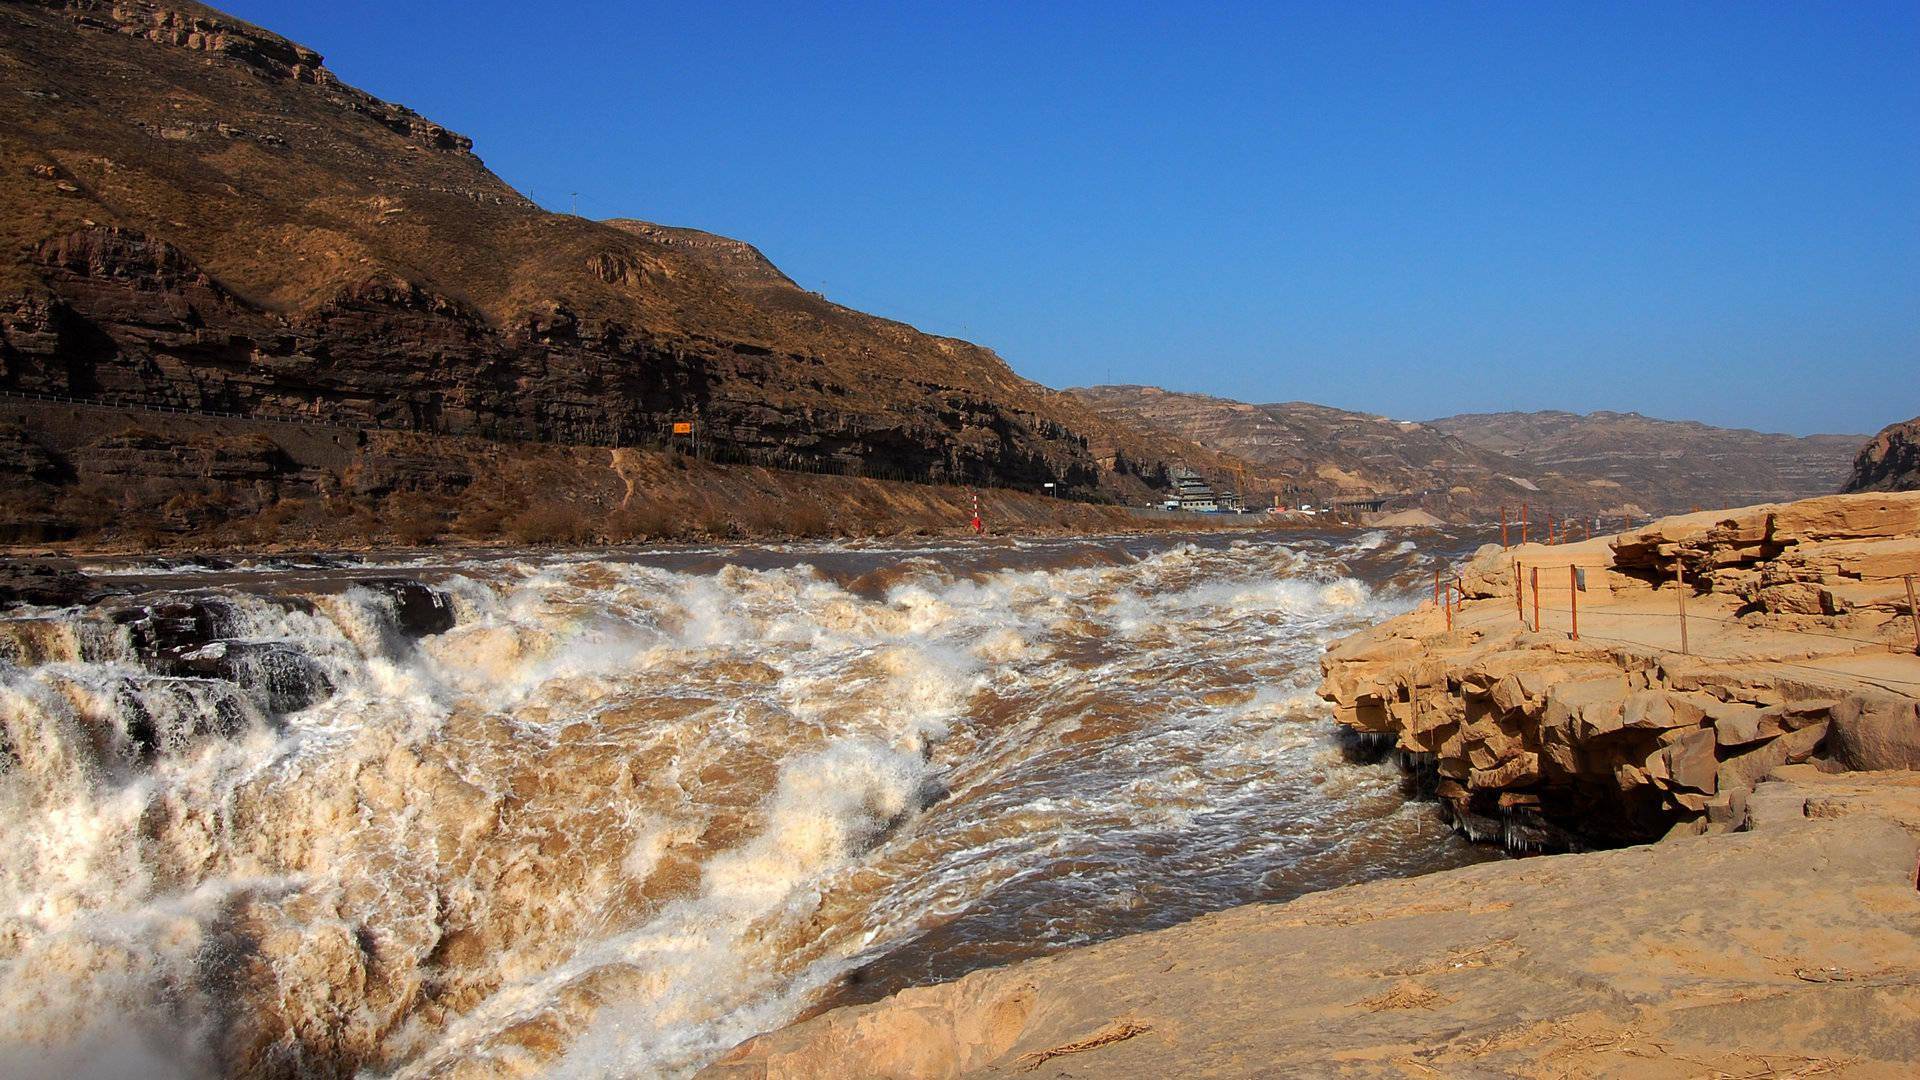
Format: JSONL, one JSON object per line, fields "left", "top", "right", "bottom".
{"left": 0, "top": 532, "right": 1486, "bottom": 1076}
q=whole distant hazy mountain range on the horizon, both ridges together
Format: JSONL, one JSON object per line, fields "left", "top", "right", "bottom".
{"left": 1069, "top": 386, "right": 1864, "bottom": 517}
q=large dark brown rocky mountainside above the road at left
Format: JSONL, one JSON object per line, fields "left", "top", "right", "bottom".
{"left": 0, "top": 0, "right": 1212, "bottom": 534}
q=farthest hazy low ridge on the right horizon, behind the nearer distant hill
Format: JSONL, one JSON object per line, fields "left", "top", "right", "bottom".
{"left": 1427, "top": 411, "right": 1860, "bottom": 513}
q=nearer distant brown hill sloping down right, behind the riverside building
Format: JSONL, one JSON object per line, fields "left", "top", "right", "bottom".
{"left": 1069, "top": 386, "right": 1645, "bottom": 521}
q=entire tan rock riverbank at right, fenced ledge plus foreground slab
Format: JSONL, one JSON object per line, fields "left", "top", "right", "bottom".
{"left": 707, "top": 496, "right": 1920, "bottom": 1078}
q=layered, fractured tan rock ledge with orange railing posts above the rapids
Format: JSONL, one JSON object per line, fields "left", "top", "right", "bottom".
{"left": 1321, "top": 494, "right": 1920, "bottom": 847}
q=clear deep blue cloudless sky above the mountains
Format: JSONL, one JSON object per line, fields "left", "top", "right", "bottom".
{"left": 227, "top": 0, "right": 1920, "bottom": 432}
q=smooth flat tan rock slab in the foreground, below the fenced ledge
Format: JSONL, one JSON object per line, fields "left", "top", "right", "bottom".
{"left": 703, "top": 810, "right": 1920, "bottom": 1080}
